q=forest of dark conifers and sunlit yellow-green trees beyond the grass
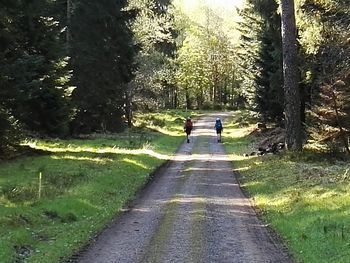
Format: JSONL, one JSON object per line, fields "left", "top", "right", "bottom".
{"left": 0, "top": 0, "right": 350, "bottom": 156}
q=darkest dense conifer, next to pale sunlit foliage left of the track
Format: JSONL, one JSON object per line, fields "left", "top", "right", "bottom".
{"left": 70, "top": 0, "right": 135, "bottom": 132}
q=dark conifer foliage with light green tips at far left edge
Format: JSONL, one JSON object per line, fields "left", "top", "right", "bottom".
{"left": 0, "top": 0, "right": 71, "bottom": 136}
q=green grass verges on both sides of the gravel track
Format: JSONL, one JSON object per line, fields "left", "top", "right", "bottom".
{"left": 6, "top": 111, "right": 350, "bottom": 263}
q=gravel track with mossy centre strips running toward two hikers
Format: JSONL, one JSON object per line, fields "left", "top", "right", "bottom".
{"left": 73, "top": 115, "right": 292, "bottom": 263}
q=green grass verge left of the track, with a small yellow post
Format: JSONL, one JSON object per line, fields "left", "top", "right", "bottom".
{"left": 0, "top": 111, "right": 200, "bottom": 263}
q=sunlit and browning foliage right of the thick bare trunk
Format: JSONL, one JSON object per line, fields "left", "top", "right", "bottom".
{"left": 298, "top": 0, "right": 350, "bottom": 153}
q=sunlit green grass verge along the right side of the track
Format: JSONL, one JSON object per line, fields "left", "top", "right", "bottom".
{"left": 224, "top": 111, "right": 350, "bottom": 263}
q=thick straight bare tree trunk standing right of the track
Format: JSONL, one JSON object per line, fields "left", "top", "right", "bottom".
{"left": 281, "top": 0, "right": 302, "bottom": 151}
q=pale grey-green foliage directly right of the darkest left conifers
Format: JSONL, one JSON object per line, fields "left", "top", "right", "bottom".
{"left": 128, "top": 0, "right": 177, "bottom": 110}
